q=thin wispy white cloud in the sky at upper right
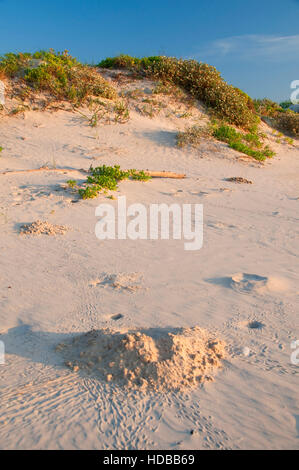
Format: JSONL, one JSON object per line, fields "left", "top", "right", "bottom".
{"left": 196, "top": 34, "right": 299, "bottom": 62}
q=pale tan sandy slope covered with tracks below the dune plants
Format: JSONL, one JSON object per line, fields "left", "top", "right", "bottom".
{"left": 0, "top": 91, "right": 299, "bottom": 449}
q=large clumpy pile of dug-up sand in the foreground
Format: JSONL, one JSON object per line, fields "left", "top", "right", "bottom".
{"left": 56, "top": 327, "right": 225, "bottom": 391}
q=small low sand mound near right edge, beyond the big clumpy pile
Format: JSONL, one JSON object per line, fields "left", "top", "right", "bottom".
{"left": 231, "top": 273, "right": 288, "bottom": 293}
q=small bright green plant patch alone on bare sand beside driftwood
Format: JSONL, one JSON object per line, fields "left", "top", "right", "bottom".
{"left": 78, "top": 165, "right": 150, "bottom": 199}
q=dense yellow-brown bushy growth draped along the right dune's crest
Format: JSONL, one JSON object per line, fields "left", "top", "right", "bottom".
{"left": 99, "top": 55, "right": 258, "bottom": 129}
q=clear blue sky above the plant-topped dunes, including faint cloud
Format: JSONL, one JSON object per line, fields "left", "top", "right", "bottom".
{"left": 0, "top": 0, "right": 299, "bottom": 101}
